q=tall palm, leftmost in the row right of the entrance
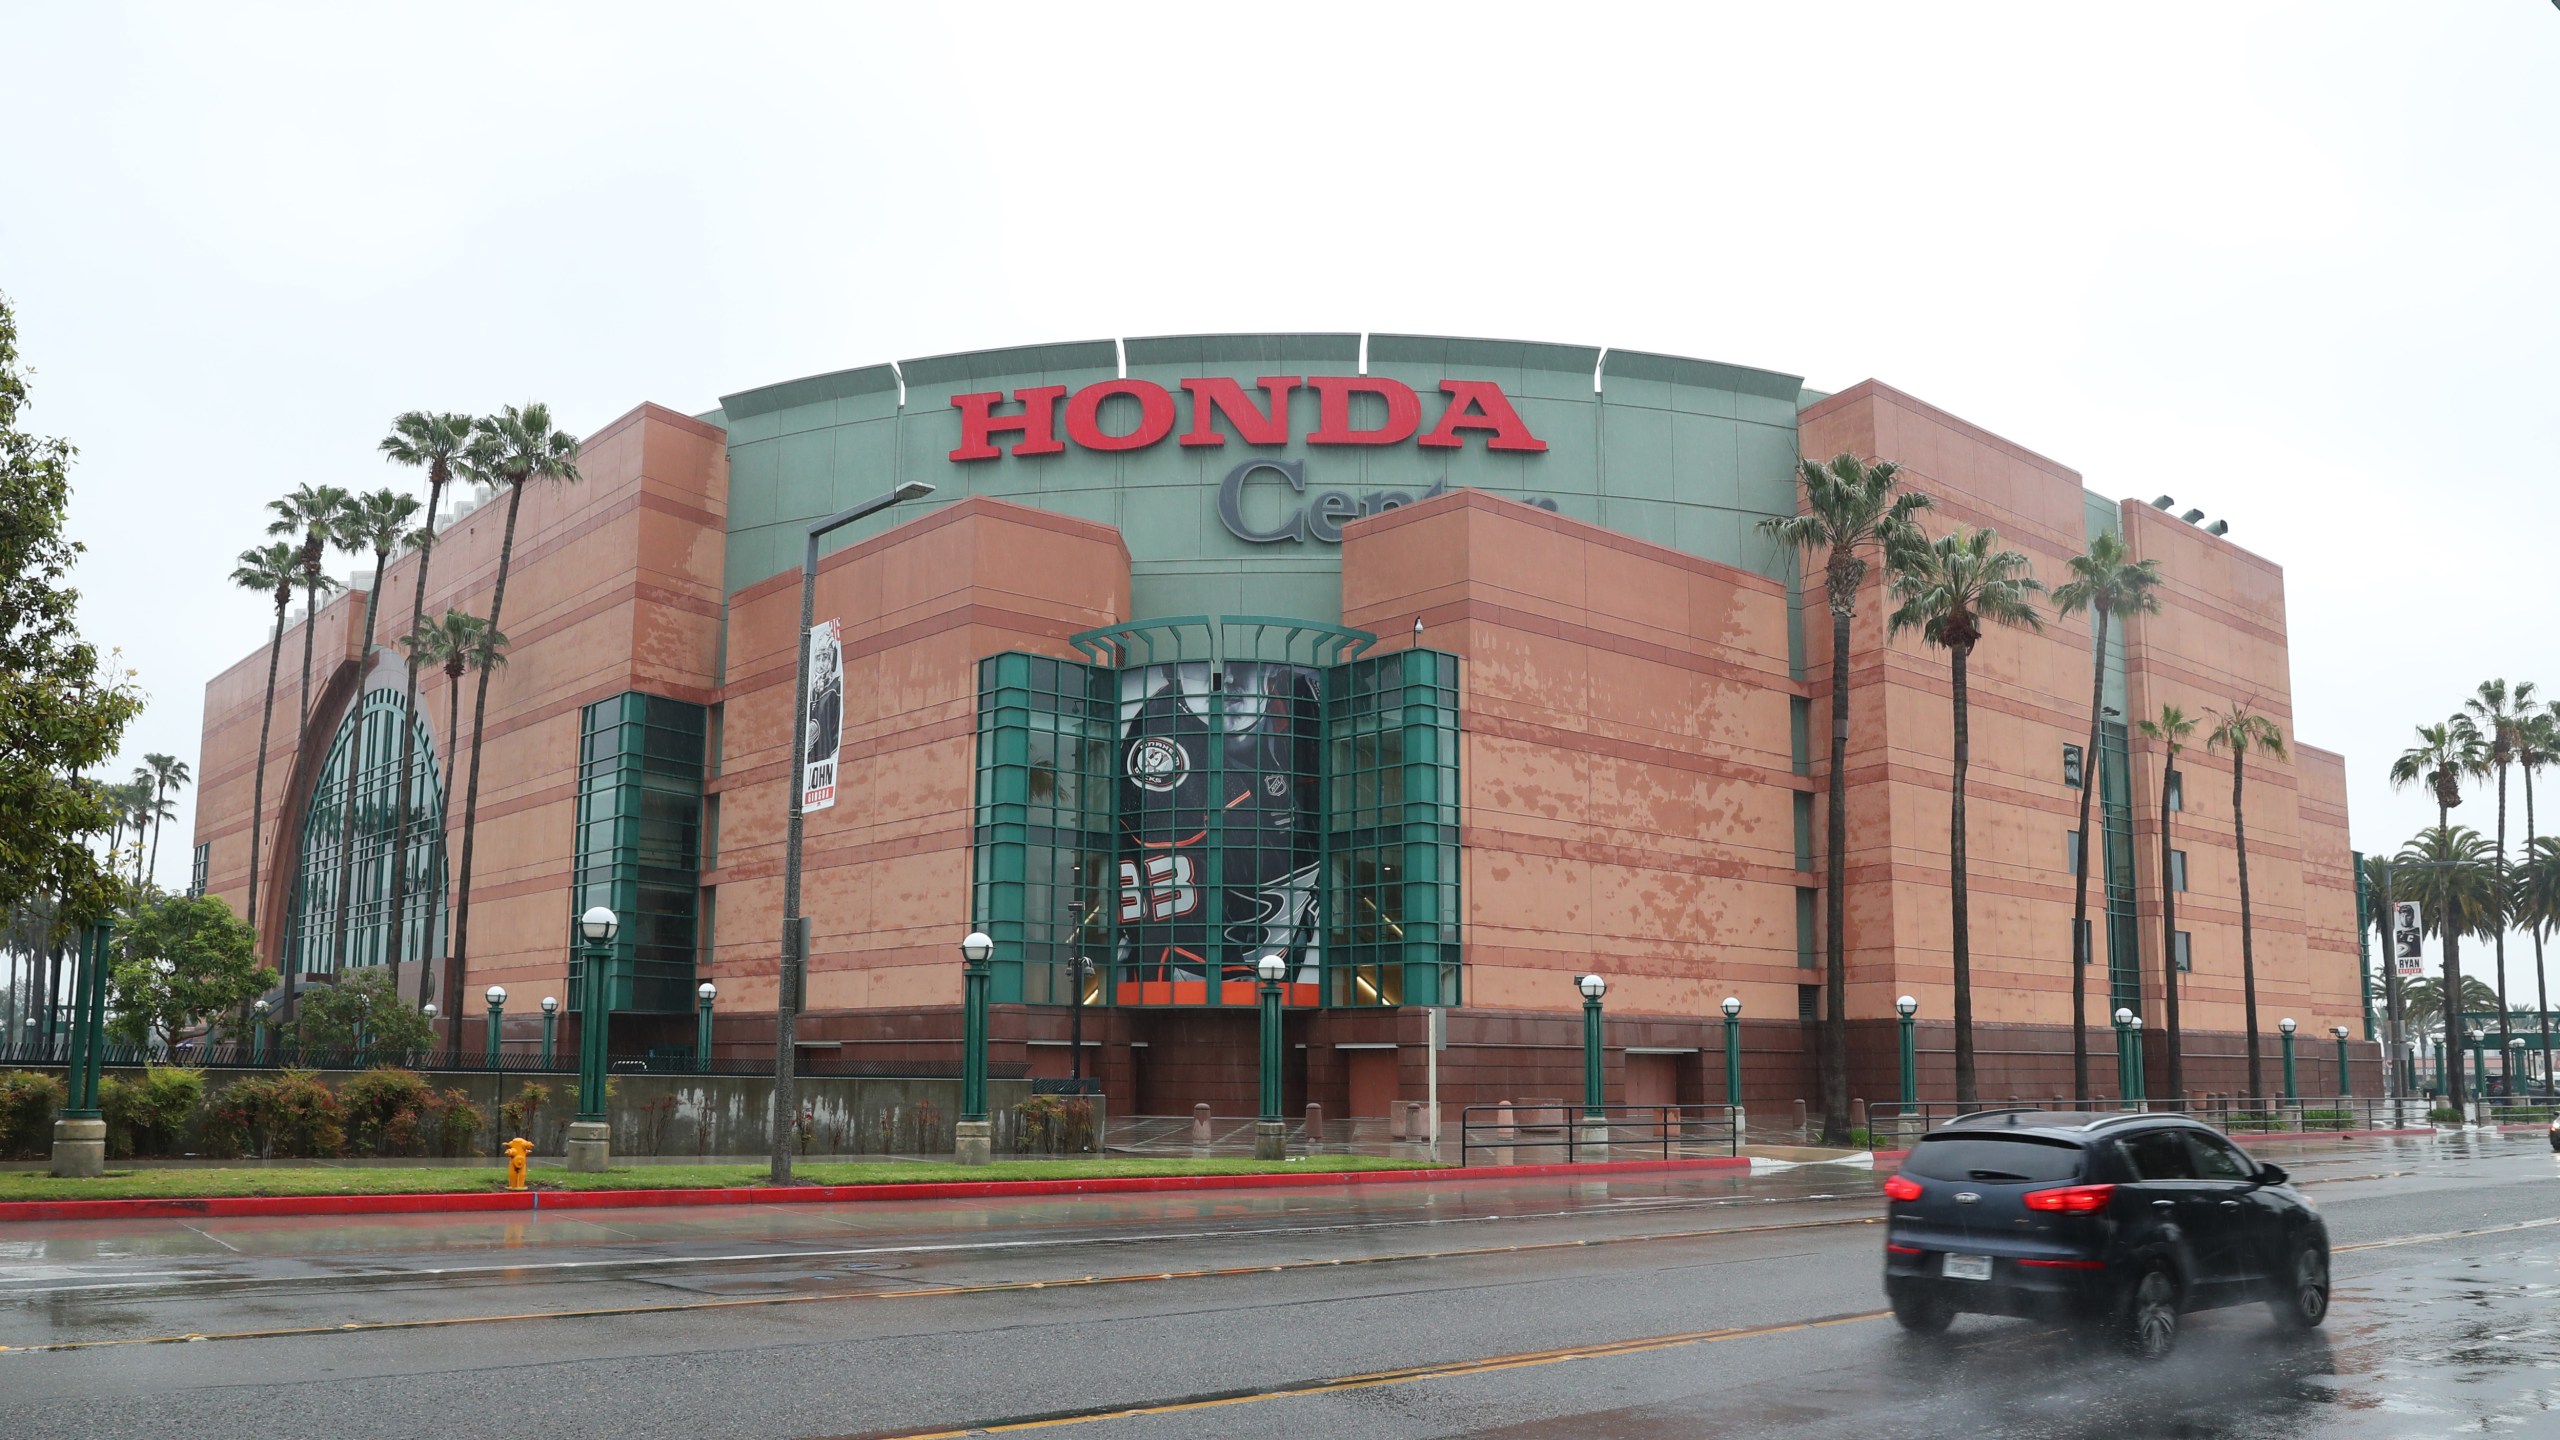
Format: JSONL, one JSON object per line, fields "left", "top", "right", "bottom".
{"left": 1761, "top": 451, "right": 1930, "bottom": 1145}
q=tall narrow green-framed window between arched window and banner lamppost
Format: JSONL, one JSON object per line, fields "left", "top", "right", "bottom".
{"left": 563, "top": 689, "right": 709, "bottom": 1015}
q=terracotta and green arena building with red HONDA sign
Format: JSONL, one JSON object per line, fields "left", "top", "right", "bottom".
{"left": 195, "top": 333, "right": 2378, "bottom": 1115}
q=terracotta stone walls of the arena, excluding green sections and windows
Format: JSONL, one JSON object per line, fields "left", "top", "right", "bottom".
{"left": 197, "top": 371, "right": 2376, "bottom": 1115}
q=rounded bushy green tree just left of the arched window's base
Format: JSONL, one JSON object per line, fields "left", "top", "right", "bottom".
{"left": 108, "top": 894, "right": 276, "bottom": 1056}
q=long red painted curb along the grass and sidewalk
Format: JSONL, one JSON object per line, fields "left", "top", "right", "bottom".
{"left": 0, "top": 1156, "right": 1751, "bottom": 1222}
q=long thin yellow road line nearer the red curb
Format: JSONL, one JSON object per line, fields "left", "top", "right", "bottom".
{"left": 0, "top": 1215, "right": 1884, "bottom": 1355}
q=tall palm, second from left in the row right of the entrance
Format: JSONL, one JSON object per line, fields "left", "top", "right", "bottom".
{"left": 1887, "top": 525, "right": 2045, "bottom": 1104}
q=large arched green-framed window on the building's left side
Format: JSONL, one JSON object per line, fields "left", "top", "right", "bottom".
{"left": 288, "top": 687, "right": 445, "bottom": 974}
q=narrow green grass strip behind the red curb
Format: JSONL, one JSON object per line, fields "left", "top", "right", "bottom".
{"left": 0, "top": 1156, "right": 1431, "bottom": 1202}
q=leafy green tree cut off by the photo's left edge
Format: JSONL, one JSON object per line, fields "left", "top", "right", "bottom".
{"left": 0, "top": 297, "right": 141, "bottom": 925}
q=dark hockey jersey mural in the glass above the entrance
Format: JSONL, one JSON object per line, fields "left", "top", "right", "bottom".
{"left": 1116, "top": 661, "right": 1324, "bottom": 1004}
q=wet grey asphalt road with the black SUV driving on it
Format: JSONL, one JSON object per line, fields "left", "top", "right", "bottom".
{"left": 0, "top": 1135, "right": 2560, "bottom": 1440}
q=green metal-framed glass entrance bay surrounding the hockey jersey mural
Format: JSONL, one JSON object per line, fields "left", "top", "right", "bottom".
{"left": 973, "top": 615, "right": 1462, "bottom": 1007}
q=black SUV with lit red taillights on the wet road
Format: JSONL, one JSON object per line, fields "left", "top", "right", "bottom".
{"left": 1884, "top": 1109, "right": 2330, "bottom": 1355}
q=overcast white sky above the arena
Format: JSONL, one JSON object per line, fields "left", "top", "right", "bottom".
{"left": 0, "top": 0, "right": 2560, "bottom": 958}
